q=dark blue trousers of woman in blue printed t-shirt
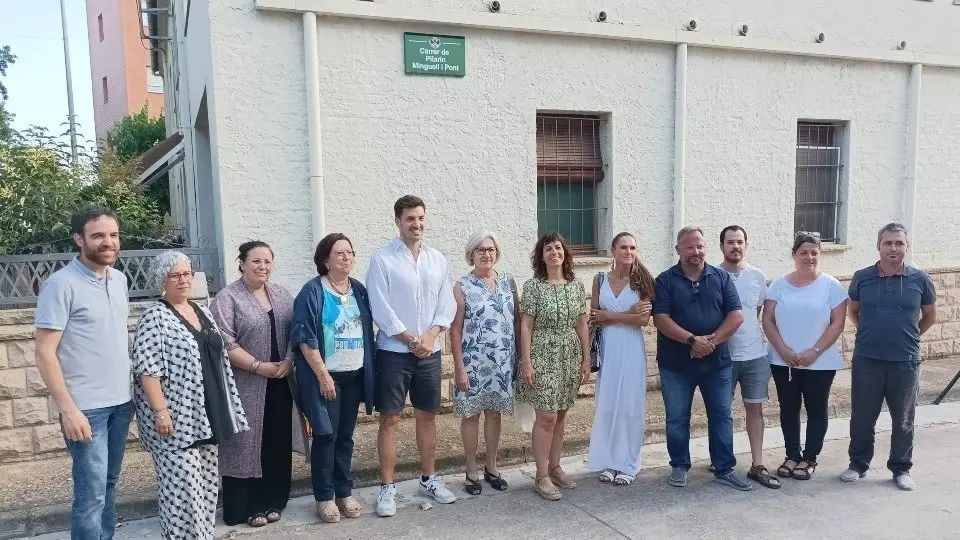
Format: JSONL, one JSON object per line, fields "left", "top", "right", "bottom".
{"left": 310, "top": 369, "right": 363, "bottom": 501}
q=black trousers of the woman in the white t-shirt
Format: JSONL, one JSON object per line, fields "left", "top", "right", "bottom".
{"left": 770, "top": 366, "right": 837, "bottom": 463}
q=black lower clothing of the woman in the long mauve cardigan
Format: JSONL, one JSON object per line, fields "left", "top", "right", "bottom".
{"left": 222, "top": 379, "right": 293, "bottom": 525}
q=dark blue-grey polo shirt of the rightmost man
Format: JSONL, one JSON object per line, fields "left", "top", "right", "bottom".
{"left": 849, "top": 265, "right": 937, "bottom": 362}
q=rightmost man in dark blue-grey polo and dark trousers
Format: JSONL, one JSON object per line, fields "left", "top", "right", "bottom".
{"left": 840, "top": 223, "right": 937, "bottom": 491}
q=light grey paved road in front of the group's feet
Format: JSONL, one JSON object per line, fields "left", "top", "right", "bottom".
{"left": 26, "top": 403, "right": 960, "bottom": 540}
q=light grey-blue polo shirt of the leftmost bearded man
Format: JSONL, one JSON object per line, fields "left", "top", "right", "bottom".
{"left": 36, "top": 258, "right": 131, "bottom": 411}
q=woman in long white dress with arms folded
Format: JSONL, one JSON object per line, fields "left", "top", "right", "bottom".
{"left": 589, "top": 232, "right": 654, "bottom": 485}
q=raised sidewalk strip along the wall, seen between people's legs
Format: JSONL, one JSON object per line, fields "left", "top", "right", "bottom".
{"left": 0, "top": 357, "right": 960, "bottom": 540}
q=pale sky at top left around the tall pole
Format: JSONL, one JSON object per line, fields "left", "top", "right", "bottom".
{"left": 0, "top": 0, "right": 95, "bottom": 140}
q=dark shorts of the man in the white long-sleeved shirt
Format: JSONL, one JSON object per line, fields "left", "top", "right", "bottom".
{"left": 375, "top": 349, "right": 441, "bottom": 414}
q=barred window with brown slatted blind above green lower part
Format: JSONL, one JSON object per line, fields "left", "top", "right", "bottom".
{"left": 537, "top": 114, "right": 604, "bottom": 253}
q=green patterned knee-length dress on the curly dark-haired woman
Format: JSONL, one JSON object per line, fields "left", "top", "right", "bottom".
{"left": 517, "top": 278, "right": 587, "bottom": 411}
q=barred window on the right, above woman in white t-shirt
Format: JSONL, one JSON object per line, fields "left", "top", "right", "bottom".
{"left": 794, "top": 122, "right": 843, "bottom": 242}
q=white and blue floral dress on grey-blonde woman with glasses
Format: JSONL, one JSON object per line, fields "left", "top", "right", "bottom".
{"left": 453, "top": 272, "right": 517, "bottom": 418}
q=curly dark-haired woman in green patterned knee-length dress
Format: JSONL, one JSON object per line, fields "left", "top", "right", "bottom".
{"left": 517, "top": 233, "right": 590, "bottom": 501}
